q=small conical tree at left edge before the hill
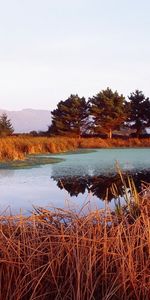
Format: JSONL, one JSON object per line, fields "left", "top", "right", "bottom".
{"left": 0, "top": 113, "right": 14, "bottom": 137}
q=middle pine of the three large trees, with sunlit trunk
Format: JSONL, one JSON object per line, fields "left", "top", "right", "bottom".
{"left": 89, "top": 88, "right": 126, "bottom": 138}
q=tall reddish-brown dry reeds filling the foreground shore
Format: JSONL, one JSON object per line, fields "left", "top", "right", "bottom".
{"left": 0, "top": 192, "right": 150, "bottom": 300}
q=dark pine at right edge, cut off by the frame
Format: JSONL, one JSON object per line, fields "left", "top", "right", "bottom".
{"left": 127, "top": 90, "right": 150, "bottom": 136}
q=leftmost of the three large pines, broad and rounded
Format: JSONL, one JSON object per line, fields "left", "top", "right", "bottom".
{"left": 48, "top": 95, "right": 88, "bottom": 137}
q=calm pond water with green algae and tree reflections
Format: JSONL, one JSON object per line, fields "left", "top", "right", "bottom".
{"left": 0, "top": 148, "right": 150, "bottom": 213}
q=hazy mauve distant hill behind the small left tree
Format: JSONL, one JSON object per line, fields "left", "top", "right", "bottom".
{"left": 0, "top": 109, "right": 51, "bottom": 133}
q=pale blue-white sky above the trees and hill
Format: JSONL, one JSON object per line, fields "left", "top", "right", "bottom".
{"left": 0, "top": 0, "right": 150, "bottom": 110}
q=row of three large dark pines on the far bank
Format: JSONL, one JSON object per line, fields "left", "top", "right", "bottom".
{"left": 48, "top": 88, "right": 150, "bottom": 138}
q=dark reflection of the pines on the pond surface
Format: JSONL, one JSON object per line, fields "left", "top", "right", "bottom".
{"left": 51, "top": 170, "right": 150, "bottom": 201}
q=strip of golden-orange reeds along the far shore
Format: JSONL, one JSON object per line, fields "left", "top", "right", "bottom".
{"left": 0, "top": 136, "right": 150, "bottom": 161}
